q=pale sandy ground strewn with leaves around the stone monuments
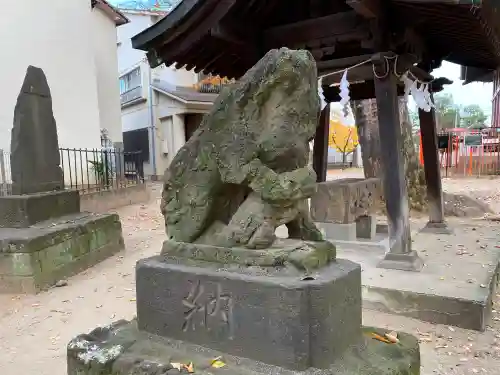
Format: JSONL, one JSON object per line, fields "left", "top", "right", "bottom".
{"left": 0, "top": 179, "right": 500, "bottom": 375}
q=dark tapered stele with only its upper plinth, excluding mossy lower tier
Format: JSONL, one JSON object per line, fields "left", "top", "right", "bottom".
{"left": 0, "top": 65, "right": 80, "bottom": 228}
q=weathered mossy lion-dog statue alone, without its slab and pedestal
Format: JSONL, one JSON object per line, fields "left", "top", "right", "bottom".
{"left": 161, "top": 48, "right": 322, "bottom": 249}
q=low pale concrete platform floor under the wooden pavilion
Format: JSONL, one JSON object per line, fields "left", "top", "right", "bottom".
{"left": 337, "top": 219, "right": 500, "bottom": 331}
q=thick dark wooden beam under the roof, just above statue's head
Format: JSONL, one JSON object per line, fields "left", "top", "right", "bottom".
{"left": 264, "top": 11, "right": 368, "bottom": 45}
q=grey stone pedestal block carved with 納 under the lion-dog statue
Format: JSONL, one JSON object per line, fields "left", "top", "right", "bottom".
{"left": 136, "top": 256, "right": 361, "bottom": 371}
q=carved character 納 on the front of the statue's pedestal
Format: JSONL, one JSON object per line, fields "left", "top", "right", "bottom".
{"left": 182, "top": 281, "right": 233, "bottom": 338}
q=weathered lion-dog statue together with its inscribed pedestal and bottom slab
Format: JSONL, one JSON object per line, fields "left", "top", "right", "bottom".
{"left": 68, "top": 48, "right": 420, "bottom": 375}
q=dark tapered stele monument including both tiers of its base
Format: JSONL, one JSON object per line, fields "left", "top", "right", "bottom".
{"left": 0, "top": 66, "right": 123, "bottom": 293}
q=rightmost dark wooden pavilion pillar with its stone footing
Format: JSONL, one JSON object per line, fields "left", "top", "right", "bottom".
{"left": 418, "top": 101, "right": 451, "bottom": 234}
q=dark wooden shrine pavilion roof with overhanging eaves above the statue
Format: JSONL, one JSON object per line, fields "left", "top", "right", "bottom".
{"left": 132, "top": 0, "right": 500, "bottom": 77}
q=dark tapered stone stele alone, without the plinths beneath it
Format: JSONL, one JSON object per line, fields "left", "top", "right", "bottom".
{"left": 10, "top": 66, "right": 64, "bottom": 195}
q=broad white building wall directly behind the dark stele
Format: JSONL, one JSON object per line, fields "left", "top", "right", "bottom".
{"left": 0, "top": 0, "right": 100, "bottom": 150}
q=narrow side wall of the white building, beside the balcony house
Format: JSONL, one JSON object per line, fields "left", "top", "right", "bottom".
{"left": 92, "top": 8, "right": 123, "bottom": 143}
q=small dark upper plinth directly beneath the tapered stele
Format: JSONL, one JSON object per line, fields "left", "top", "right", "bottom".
{"left": 0, "top": 191, "right": 80, "bottom": 228}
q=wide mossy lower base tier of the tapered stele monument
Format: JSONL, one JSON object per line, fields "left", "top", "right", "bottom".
{"left": 0, "top": 213, "right": 124, "bottom": 293}
